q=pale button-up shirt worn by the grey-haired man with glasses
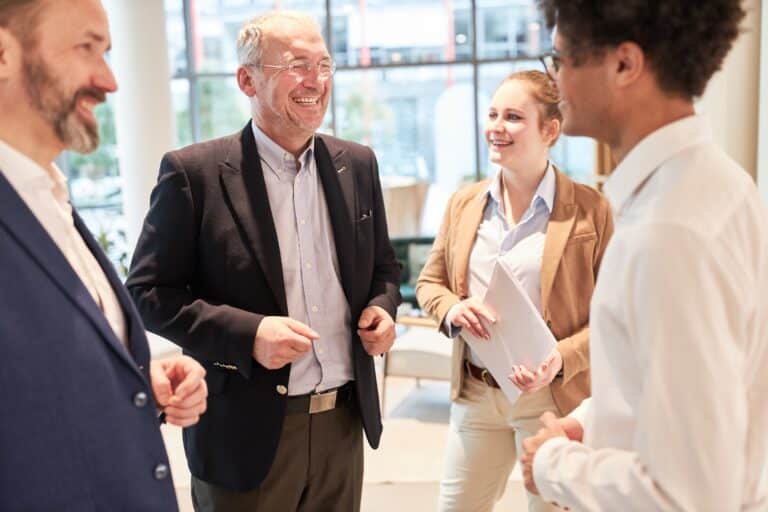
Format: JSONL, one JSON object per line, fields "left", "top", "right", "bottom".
{"left": 251, "top": 123, "right": 353, "bottom": 395}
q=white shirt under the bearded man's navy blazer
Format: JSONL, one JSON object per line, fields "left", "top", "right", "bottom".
{"left": 0, "top": 141, "right": 128, "bottom": 345}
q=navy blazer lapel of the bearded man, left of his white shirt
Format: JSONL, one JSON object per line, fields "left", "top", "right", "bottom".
{"left": 0, "top": 174, "right": 140, "bottom": 374}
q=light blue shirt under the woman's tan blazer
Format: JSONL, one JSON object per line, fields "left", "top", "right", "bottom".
{"left": 450, "top": 163, "right": 556, "bottom": 368}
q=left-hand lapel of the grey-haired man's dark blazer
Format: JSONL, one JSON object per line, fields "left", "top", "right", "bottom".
{"left": 219, "top": 123, "right": 288, "bottom": 315}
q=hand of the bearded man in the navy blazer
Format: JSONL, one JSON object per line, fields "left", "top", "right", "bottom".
{"left": 149, "top": 356, "right": 208, "bottom": 427}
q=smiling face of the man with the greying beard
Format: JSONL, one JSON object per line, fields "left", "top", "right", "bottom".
{"left": 16, "top": 0, "right": 117, "bottom": 153}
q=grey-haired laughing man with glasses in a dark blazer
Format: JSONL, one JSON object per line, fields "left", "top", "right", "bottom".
{"left": 128, "top": 12, "right": 400, "bottom": 512}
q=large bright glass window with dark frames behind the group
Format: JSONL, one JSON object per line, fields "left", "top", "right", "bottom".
{"left": 170, "top": 0, "right": 595, "bottom": 236}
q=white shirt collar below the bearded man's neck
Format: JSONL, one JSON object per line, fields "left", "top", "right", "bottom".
{"left": 0, "top": 140, "right": 69, "bottom": 202}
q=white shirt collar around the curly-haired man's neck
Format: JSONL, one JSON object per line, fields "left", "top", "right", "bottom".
{"left": 603, "top": 115, "right": 712, "bottom": 214}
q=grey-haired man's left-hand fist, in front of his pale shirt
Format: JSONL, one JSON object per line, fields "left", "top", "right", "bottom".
{"left": 253, "top": 316, "right": 320, "bottom": 370}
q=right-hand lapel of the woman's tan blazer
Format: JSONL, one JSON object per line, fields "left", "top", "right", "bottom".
{"left": 541, "top": 169, "right": 576, "bottom": 311}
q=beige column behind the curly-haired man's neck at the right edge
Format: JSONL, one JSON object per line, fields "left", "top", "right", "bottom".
{"left": 696, "top": 0, "right": 761, "bottom": 177}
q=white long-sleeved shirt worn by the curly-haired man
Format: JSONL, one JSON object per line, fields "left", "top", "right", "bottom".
{"left": 533, "top": 116, "right": 768, "bottom": 512}
